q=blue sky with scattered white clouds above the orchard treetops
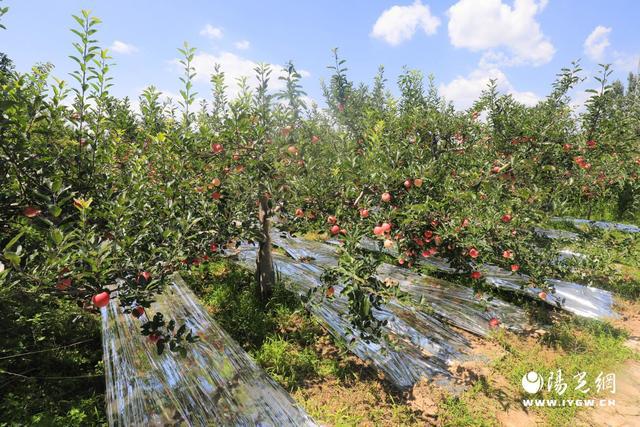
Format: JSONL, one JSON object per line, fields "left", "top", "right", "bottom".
{"left": 0, "top": 0, "right": 640, "bottom": 108}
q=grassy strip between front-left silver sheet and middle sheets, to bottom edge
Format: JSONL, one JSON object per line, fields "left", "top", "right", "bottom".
{"left": 184, "top": 261, "right": 430, "bottom": 426}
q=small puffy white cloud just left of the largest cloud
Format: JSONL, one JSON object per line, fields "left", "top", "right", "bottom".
{"left": 371, "top": 0, "right": 440, "bottom": 46}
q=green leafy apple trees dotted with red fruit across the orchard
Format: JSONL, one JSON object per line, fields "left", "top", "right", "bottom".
{"left": 0, "top": 7, "right": 640, "bottom": 424}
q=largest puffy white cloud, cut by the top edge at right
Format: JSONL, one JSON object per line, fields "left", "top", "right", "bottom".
{"left": 447, "top": 0, "right": 555, "bottom": 66}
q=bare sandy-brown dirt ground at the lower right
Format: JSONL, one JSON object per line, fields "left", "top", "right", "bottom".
{"left": 294, "top": 303, "right": 640, "bottom": 427}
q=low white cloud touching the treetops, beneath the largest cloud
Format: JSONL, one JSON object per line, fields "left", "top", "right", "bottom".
{"left": 439, "top": 68, "right": 540, "bottom": 110}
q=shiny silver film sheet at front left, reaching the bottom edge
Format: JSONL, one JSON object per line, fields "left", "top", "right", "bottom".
{"left": 102, "top": 275, "right": 315, "bottom": 427}
